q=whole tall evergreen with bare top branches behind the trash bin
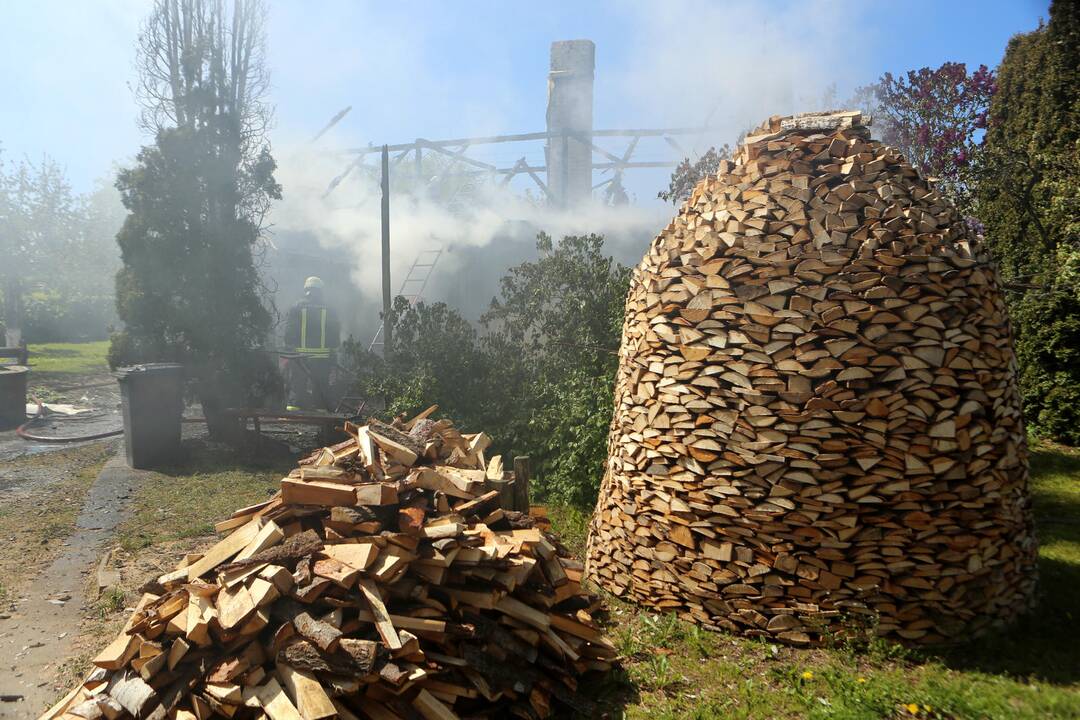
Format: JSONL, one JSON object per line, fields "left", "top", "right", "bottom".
{"left": 110, "top": 0, "right": 281, "bottom": 434}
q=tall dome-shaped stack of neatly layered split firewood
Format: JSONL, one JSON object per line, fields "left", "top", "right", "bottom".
{"left": 588, "top": 112, "right": 1036, "bottom": 644}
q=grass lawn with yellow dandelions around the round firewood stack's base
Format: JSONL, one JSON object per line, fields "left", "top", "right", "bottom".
{"left": 550, "top": 446, "right": 1080, "bottom": 720}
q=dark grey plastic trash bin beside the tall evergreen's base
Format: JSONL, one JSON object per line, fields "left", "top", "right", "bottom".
{"left": 114, "top": 363, "right": 184, "bottom": 470}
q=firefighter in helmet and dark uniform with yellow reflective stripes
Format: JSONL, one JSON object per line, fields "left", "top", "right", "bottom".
{"left": 285, "top": 276, "right": 341, "bottom": 410}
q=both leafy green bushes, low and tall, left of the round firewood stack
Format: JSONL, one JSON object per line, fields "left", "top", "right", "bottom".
{"left": 342, "top": 234, "right": 630, "bottom": 506}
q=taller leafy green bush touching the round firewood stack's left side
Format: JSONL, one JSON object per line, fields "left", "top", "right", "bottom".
{"left": 483, "top": 233, "right": 630, "bottom": 505}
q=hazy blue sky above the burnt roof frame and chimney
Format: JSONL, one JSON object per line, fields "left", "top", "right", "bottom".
{"left": 0, "top": 0, "right": 1048, "bottom": 196}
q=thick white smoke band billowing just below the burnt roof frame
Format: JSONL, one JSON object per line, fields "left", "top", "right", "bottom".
{"left": 270, "top": 138, "right": 669, "bottom": 313}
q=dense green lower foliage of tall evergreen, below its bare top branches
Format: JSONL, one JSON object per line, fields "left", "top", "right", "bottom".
{"left": 109, "top": 128, "right": 280, "bottom": 399}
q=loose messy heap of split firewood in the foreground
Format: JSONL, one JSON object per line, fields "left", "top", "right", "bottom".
{"left": 42, "top": 412, "right": 616, "bottom": 720}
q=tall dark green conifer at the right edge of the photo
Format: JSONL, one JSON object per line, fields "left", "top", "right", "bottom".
{"left": 976, "top": 2, "right": 1080, "bottom": 445}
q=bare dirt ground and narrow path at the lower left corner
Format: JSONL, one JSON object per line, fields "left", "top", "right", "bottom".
{"left": 0, "top": 371, "right": 134, "bottom": 718}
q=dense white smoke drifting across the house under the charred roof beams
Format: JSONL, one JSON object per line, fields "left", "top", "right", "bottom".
{"left": 264, "top": 136, "right": 670, "bottom": 325}
